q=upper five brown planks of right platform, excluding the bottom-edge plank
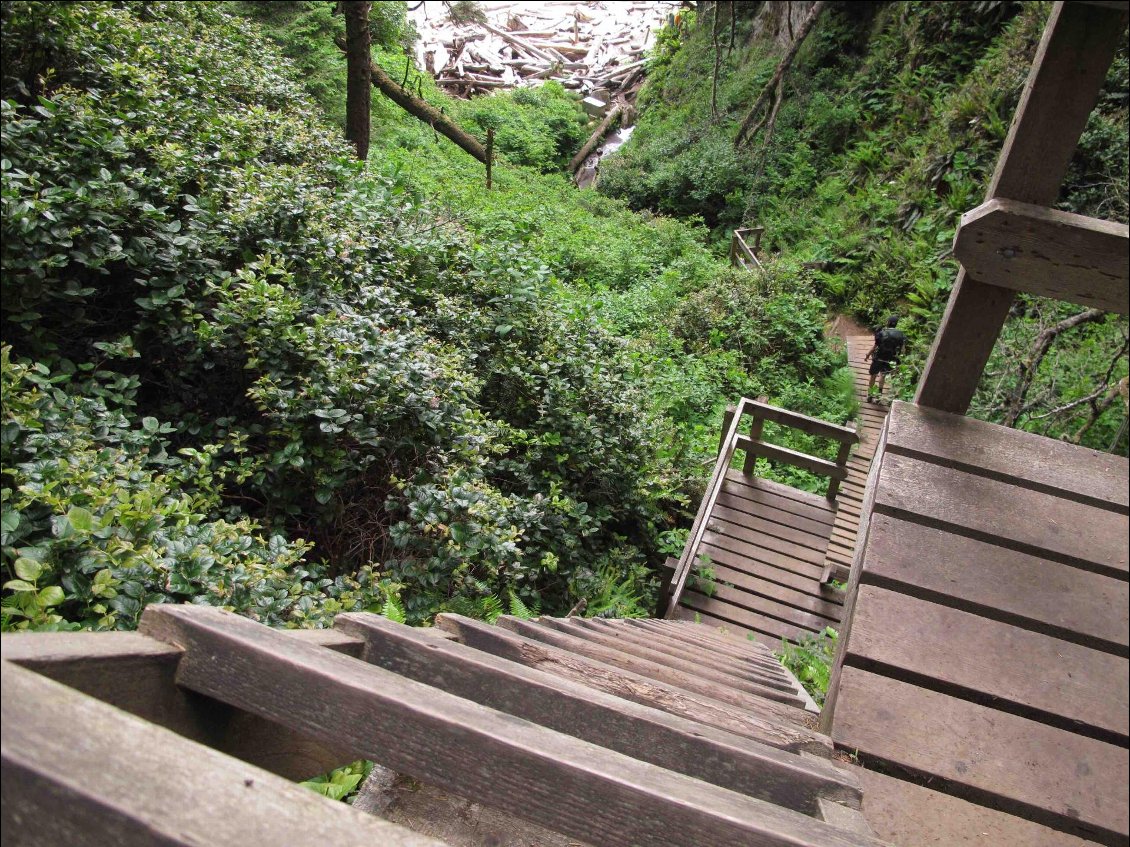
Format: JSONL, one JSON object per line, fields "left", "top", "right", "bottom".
{"left": 824, "top": 403, "right": 1130, "bottom": 845}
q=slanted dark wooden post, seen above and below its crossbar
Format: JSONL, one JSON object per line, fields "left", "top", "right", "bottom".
{"left": 914, "top": 2, "right": 1127, "bottom": 414}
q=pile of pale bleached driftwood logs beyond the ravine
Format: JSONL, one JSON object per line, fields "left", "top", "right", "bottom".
{"left": 412, "top": 1, "right": 679, "bottom": 102}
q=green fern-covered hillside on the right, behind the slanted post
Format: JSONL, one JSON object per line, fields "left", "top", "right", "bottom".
{"left": 600, "top": 2, "right": 1130, "bottom": 455}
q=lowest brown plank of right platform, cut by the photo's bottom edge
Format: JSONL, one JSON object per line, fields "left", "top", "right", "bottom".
{"left": 842, "top": 765, "right": 1095, "bottom": 847}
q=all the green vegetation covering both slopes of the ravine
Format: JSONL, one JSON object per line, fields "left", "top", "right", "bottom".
{"left": 0, "top": 0, "right": 1125, "bottom": 629}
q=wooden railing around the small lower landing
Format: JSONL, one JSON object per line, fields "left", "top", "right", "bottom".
{"left": 666, "top": 398, "right": 859, "bottom": 618}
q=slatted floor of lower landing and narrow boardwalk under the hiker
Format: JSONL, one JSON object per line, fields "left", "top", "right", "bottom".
{"left": 675, "top": 335, "right": 887, "bottom": 646}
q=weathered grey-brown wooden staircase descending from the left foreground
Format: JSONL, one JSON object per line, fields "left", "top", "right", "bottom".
{"left": 0, "top": 605, "right": 879, "bottom": 847}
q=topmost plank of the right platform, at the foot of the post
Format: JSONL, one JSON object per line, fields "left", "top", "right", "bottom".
{"left": 887, "top": 403, "right": 1130, "bottom": 514}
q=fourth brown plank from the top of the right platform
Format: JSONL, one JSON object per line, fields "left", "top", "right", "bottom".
{"left": 844, "top": 585, "right": 1130, "bottom": 746}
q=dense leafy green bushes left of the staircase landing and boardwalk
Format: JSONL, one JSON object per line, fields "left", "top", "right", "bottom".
{"left": 0, "top": 2, "right": 850, "bottom": 628}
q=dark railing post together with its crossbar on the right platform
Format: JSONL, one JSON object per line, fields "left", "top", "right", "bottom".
{"left": 914, "top": 2, "right": 1128, "bottom": 414}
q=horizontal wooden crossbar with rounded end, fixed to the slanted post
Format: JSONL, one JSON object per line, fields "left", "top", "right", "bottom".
{"left": 954, "top": 199, "right": 1130, "bottom": 314}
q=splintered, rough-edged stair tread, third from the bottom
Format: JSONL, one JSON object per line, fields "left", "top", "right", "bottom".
{"left": 436, "top": 614, "right": 832, "bottom": 757}
